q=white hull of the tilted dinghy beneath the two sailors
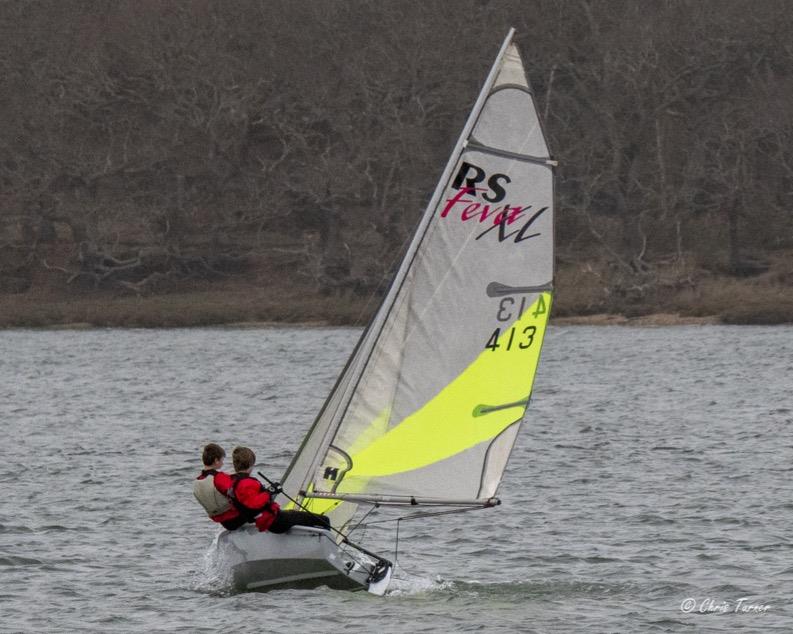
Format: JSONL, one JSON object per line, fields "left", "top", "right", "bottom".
{"left": 217, "top": 526, "right": 391, "bottom": 595}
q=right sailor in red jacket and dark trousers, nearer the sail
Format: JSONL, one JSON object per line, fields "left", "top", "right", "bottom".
{"left": 226, "top": 447, "right": 330, "bottom": 533}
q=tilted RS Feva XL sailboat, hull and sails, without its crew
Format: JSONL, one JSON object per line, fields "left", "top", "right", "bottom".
{"left": 213, "top": 29, "right": 556, "bottom": 594}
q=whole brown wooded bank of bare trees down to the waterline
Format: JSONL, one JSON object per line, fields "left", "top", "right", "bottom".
{"left": 0, "top": 0, "right": 793, "bottom": 326}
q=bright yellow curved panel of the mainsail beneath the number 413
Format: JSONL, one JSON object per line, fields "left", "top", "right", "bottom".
{"left": 337, "top": 293, "right": 551, "bottom": 482}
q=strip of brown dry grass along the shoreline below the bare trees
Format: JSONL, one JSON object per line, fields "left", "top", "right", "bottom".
{"left": 0, "top": 271, "right": 793, "bottom": 328}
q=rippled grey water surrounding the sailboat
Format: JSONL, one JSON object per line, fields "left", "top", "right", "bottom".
{"left": 0, "top": 326, "right": 793, "bottom": 633}
